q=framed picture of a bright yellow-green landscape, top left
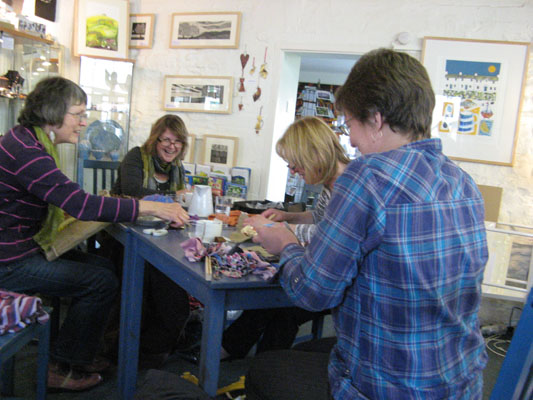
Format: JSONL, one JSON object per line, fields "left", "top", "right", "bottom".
{"left": 73, "top": 0, "right": 130, "bottom": 59}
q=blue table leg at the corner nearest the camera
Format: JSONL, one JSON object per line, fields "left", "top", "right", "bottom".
{"left": 199, "top": 290, "right": 226, "bottom": 397}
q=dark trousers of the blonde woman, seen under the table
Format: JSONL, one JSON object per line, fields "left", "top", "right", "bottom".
{"left": 222, "top": 307, "right": 329, "bottom": 358}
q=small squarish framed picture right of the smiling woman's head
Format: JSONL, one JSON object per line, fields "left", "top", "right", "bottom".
{"left": 201, "top": 135, "right": 239, "bottom": 169}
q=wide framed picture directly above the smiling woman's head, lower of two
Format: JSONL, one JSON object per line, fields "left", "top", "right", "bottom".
{"left": 163, "top": 75, "right": 233, "bottom": 114}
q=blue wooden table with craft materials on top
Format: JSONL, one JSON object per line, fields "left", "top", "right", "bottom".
{"left": 107, "top": 224, "right": 292, "bottom": 399}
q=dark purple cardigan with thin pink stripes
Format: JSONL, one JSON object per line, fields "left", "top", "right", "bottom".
{"left": 0, "top": 125, "right": 139, "bottom": 266}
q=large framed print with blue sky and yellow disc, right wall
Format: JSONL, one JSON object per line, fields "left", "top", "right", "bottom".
{"left": 422, "top": 37, "right": 529, "bottom": 166}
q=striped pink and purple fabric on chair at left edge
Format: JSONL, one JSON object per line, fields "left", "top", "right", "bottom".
{"left": 0, "top": 290, "right": 50, "bottom": 335}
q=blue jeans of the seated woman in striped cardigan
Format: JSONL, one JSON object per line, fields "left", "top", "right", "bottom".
{"left": 0, "top": 250, "right": 119, "bottom": 365}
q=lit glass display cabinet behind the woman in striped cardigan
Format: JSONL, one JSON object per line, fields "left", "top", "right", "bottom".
{"left": 0, "top": 27, "right": 61, "bottom": 135}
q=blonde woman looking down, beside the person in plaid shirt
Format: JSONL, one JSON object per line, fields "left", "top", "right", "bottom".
{"left": 222, "top": 117, "right": 350, "bottom": 358}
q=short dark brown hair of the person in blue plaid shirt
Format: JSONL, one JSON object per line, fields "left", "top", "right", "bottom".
{"left": 335, "top": 49, "right": 435, "bottom": 141}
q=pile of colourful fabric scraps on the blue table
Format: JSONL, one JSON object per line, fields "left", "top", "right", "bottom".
{"left": 181, "top": 238, "right": 277, "bottom": 280}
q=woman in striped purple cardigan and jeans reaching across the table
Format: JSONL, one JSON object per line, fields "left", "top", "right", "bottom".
{"left": 0, "top": 77, "right": 188, "bottom": 390}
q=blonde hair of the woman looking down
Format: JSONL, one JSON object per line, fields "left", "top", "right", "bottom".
{"left": 276, "top": 117, "right": 350, "bottom": 185}
